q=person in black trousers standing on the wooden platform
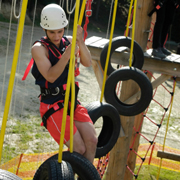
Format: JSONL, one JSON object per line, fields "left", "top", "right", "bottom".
{"left": 152, "top": 0, "right": 178, "bottom": 58}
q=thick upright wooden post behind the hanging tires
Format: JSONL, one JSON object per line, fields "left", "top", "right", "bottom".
{"left": 106, "top": 0, "right": 153, "bottom": 180}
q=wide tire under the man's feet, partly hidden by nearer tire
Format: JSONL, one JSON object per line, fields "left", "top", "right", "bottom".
{"left": 33, "top": 151, "right": 101, "bottom": 180}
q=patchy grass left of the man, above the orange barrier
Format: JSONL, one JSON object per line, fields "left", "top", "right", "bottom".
{"left": 1, "top": 115, "right": 57, "bottom": 163}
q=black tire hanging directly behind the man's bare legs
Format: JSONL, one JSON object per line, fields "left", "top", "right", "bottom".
{"left": 86, "top": 102, "right": 121, "bottom": 158}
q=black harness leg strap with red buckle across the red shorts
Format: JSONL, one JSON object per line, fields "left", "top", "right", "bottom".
{"left": 41, "top": 102, "right": 64, "bottom": 129}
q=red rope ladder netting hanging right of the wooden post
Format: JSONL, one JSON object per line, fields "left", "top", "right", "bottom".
{"left": 126, "top": 71, "right": 175, "bottom": 179}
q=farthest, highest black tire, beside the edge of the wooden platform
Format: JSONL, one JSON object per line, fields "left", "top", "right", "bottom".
{"left": 100, "top": 36, "right": 144, "bottom": 76}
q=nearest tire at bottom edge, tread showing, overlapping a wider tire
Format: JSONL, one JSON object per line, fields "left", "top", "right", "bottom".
{"left": 33, "top": 159, "right": 74, "bottom": 180}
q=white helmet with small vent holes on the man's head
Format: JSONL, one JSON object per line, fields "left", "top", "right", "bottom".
{"left": 40, "top": 4, "right": 68, "bottom": 30}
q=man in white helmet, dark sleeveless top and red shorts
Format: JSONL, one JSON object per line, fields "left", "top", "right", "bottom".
{"left": 31, "top": 4, "right": 97, "bottom": 163}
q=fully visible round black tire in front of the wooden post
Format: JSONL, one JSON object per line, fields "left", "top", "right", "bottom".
{"left": 104, "top": 67, "right": 153, "bottom": 116}
